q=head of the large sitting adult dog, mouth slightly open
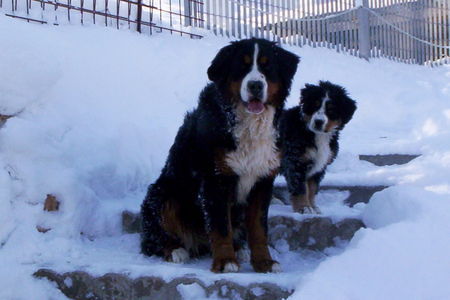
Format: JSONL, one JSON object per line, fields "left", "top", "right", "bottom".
{"left": 208, "top": 39, "right": 299, "bottom": 114}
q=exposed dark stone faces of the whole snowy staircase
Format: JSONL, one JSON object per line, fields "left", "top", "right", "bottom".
{"left": 34, "top": 154, "right": 418, "bottom": 300}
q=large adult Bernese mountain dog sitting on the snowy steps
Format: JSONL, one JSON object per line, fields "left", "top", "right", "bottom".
{"left": 141, "top": 39, "right": 299, "bottom": 272}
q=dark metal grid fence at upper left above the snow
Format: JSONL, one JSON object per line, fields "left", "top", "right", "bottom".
{"left": 0, "top": 0, "right": 203, "bottom": 38}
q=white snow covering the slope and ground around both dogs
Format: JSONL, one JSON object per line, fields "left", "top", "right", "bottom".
{"left": 0, "top": 16, "right": 450, "bottom": 299}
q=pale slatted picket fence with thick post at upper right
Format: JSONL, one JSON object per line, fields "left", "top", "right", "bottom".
{"left": 198, "top": 0, "right": 450, "bottom": 65}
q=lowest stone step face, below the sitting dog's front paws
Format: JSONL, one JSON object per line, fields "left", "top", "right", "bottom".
{"left": 34, "top": 269, "right": 293, "bottom": 300}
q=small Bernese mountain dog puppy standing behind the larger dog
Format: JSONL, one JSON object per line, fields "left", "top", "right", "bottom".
{"left": 280, "top": 81, "right": 356, "bottom": 213}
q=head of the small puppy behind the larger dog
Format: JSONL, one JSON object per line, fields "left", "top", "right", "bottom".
{"left": 300, "top": 81, "right": 356, "bottom": 133}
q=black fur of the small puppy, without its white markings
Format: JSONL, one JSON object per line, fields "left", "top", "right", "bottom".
{"left": 279, "top": 81, "right": 356, "bottom": 212}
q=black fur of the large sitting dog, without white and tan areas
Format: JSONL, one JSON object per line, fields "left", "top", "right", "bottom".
{"left": 141, "top": 39, "right": 299, "bottom": 271}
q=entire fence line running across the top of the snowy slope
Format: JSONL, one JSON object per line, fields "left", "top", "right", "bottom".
{"left": 0, "top": 0, "right": 450, "bottom": 66}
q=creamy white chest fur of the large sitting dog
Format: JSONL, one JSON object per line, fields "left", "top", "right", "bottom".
{"left": 225, "top": 105, "right": 280, "bottom": 203}
